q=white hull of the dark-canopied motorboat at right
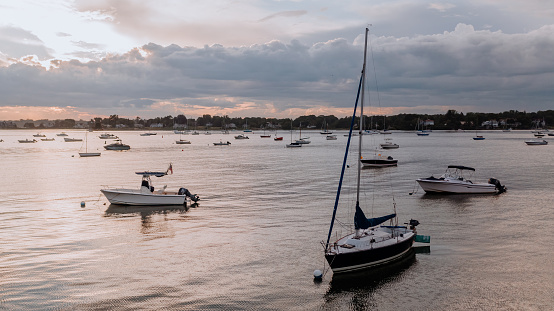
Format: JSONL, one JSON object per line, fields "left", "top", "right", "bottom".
{"left": 416, "top": 178, "right": 497, "bottom": 194}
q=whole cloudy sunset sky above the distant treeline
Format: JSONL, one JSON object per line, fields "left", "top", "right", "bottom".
{"left": 0, "top": 0, "right": 554, "bottom": 120}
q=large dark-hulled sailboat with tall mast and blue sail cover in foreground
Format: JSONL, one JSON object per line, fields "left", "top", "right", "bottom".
{"left": 322, "top": 28, "right": 419, "bottom": 276}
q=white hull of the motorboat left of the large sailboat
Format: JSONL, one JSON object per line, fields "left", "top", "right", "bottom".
{"left": 100, "top": 189, "right": 186, "bottom": 206}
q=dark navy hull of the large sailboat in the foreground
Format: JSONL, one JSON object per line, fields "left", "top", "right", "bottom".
{"left": 325, "top": 234, "right": 415, "bottom": 273}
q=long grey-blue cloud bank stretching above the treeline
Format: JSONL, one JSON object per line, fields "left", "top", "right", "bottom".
{"left": 0, "top": 24, "right": 554, "bottom": 117}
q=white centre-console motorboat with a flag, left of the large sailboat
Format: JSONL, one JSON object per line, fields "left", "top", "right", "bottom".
{"left": 100, "top": 164, "right": 200, "bottom": 206}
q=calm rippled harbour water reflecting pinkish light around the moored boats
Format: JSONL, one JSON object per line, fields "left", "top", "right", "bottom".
{"left": 0, "top": 130, "right": 554, "bottom": 310}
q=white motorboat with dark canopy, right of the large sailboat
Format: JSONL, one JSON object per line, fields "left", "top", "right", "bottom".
{"left": 416, "top": 165, "right": 506, "bottom": 194}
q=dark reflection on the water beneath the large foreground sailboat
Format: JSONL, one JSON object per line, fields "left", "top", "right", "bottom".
{"left": 324, "top": 249, "right": 416, "bottom": 310}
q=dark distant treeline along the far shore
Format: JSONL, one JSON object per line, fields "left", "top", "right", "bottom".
{"left": 4, "top": 110, "right": 554, "bottom": 130}
